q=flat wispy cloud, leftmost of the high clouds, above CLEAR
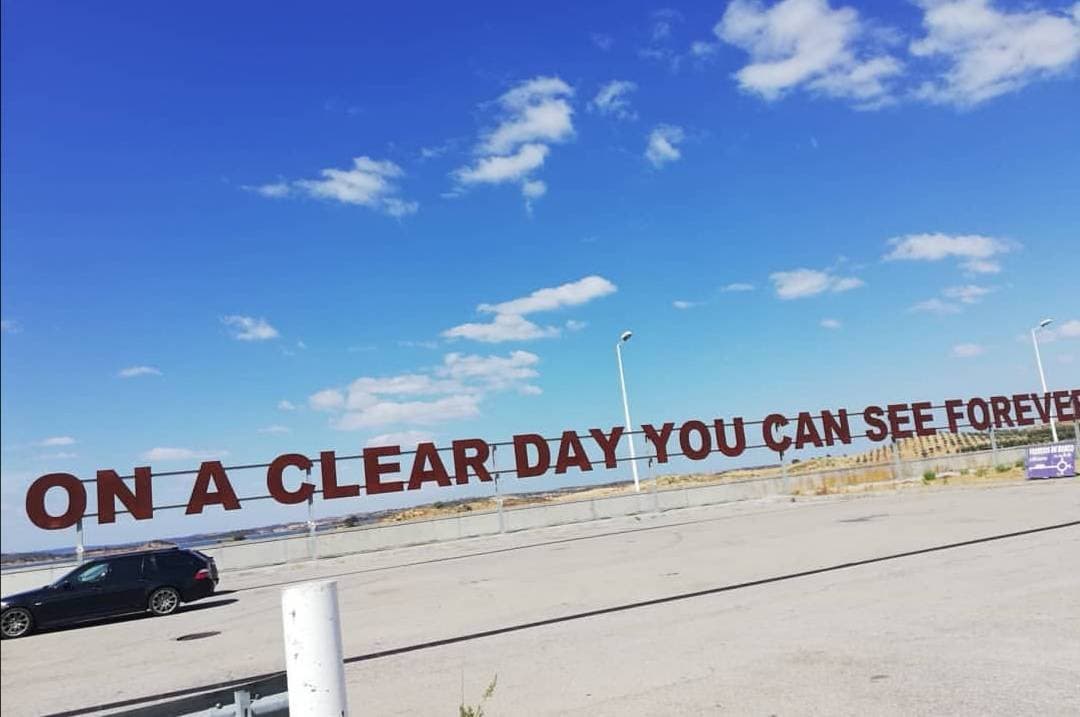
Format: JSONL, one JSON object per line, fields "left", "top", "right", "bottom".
{"left": 244, "top": 157, "right": 419, "bottom": 217}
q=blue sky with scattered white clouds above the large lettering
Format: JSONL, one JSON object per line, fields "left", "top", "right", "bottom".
{"left": 6, "top": 0, "right": 1080, "bottom": 551}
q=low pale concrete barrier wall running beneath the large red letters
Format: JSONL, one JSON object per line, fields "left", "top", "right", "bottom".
{"left": 0, "top": 447, "right": 1062, "bottom": 595}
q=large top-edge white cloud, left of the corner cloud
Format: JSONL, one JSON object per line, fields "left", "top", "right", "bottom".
{"left": 713, "top": 0, "right": 904, "bottom": 109}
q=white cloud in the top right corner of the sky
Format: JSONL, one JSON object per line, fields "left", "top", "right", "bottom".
{"left": 909, "top": 0, "right": 1080, "bottom": 107}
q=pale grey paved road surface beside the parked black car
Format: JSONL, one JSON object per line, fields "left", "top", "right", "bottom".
{"left": 2, "top": 479, "right": 1080, "bottom": 716}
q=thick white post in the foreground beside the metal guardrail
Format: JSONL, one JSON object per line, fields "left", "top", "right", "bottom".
{"left": 281, "top": 580, "right": 349, "bottom": 717}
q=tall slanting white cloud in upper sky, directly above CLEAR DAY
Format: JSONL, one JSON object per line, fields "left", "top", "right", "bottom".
{"left": 453, "top": 77, "right": 573, "bottom": 207}
